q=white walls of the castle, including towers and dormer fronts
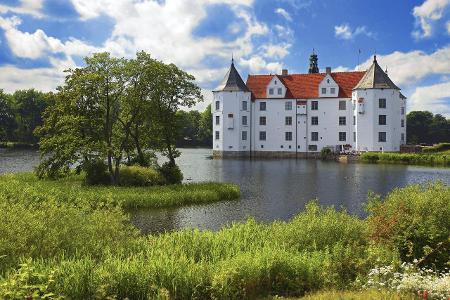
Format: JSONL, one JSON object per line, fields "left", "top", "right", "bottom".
{"left": 212, "top": 56, "right": 406, "bottom": 155}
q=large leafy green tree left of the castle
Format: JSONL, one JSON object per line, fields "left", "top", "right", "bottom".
{"left": 36, "top": 52, "right": 202, "bottom": 184}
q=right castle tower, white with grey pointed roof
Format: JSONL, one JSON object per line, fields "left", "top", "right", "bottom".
{"left": 352, "top": 55, "right": 406, "bottom": 151}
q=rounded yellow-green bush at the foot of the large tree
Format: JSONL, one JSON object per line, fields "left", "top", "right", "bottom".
{"left": 119, "top": 166, "right": 165, "bottom": 186}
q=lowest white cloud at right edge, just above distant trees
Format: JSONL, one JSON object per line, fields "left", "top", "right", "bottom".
{"left": 408, "top": 81, "right": 450, "bottom": 118}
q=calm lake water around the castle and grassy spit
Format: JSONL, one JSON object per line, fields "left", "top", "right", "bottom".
{"left": 0, "top": 149, "right": 450, "bottom": 232}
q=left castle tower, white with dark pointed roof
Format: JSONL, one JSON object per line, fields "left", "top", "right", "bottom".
{"left": 211, "top": 59, "right": 251, "bottom": 157}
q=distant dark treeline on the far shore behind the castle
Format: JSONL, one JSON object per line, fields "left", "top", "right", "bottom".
{"left": 0, "top": 89, "right": 450, "bottom": 147}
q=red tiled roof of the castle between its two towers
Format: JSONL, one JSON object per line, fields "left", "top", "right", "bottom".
{"left": 247, "top": 71, "right": 366, "bottom": 99}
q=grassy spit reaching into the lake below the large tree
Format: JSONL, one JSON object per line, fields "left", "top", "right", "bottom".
{"left": 0, "top": 173, "right": 240, "bottom": 208}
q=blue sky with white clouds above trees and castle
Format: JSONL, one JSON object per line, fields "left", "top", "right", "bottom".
{"left": 0, "top": 0, "right": 450, "bottom": 117}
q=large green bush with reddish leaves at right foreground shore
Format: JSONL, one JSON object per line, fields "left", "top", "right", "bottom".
{"left": 368, "top": 183, "right": 450, "bottom": 269}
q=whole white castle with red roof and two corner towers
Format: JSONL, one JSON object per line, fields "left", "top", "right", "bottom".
{"left": 211, "top": 52, "right": 406, "bottom": 157}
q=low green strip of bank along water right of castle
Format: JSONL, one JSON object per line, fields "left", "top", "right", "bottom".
{"left": 361, "top": 152, "right": 450, "bottom": 167}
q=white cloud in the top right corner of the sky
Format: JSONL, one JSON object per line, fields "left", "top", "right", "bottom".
{"left": 412, "top": 0, "right": 450, "bottom": 39}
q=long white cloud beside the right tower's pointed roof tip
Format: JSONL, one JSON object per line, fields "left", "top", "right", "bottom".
{"left": 359, "top": 45, "right": 450, "bottom": 85}
